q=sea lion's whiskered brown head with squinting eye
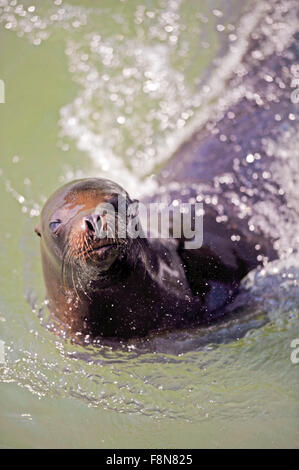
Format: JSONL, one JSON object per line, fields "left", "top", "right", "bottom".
{"left": 35, "top": 178, "right": 138, "bottom": 290}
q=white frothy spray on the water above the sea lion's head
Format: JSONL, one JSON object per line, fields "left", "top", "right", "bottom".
{"left": 0, "top": 0, "right": 258, "bottom": 196}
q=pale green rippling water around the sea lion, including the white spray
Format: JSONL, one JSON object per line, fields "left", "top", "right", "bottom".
{"left": 0, "top": 0, "right": 299, "bottom": 448}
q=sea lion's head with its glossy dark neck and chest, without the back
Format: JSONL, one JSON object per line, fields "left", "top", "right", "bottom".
{"left": 36, "top": 178, "right": 196, "bottom": 338}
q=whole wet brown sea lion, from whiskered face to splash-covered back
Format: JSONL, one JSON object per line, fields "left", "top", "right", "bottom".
{"left": 36, "top": 2, "right": 298, "bottom": 338}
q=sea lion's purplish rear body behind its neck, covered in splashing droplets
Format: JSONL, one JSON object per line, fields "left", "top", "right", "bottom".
{"left": 149, "top": 1, "right": 299, "bottom": 312}
